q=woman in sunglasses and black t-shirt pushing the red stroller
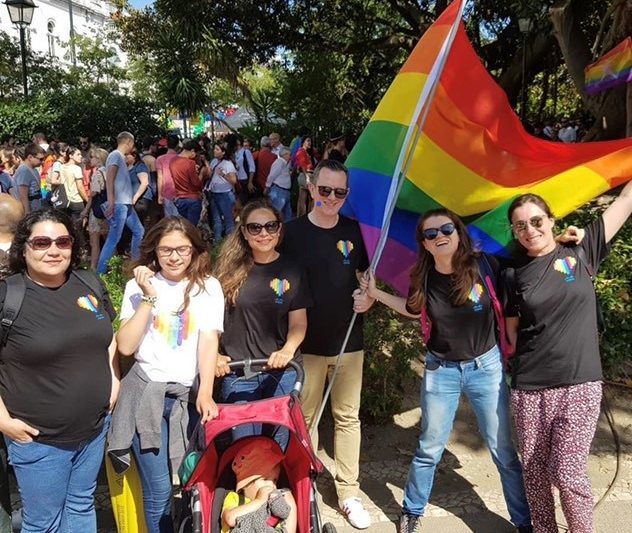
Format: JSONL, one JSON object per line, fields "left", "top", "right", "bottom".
{"left": 215, "top": 199, "right": 311, "bottom": 448}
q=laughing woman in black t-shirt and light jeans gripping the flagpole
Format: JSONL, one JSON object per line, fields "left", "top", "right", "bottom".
{"left": 361, "top": 209, "right": 532, "bottom": 533}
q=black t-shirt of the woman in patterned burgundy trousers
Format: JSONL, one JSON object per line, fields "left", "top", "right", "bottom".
{"left": 506, "top": 218, "right": 609, "bottom": 390}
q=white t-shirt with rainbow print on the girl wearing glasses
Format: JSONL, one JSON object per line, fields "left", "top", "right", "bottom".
{"left": 121, "top": 273, "right": 224, "bottom": 387}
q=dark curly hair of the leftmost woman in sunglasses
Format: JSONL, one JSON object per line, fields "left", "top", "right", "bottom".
{"left": 1, "top": 208, "right": 83, "bottom": 277}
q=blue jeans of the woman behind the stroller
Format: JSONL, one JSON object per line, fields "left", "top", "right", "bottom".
{"left": 221, "top": 368, "right": 296, "bottom": 451}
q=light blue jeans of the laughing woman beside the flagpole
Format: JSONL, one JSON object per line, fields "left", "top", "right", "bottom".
{"left": 403, "top": 347, "right": 531, "bottom": 526}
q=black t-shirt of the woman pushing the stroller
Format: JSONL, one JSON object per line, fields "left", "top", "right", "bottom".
{"left": 220, "top": 254, "right": 312, "bottom": 363}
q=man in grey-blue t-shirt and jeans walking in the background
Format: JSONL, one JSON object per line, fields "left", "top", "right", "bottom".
{"left": 97, "top": 131, "right": 145, "bottom": 274}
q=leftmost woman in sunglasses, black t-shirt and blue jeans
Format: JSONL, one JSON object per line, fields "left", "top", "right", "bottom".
{"left": 0, "top": 209, "right": 118, "bottom": 533}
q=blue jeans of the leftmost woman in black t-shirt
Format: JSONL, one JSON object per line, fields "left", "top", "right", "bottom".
{"left": 4, "top": 415, "right": 110, "bottom": 533}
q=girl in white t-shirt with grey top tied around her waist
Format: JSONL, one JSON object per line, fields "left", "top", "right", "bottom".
{"left": 108, "top": 217, "right": 224, "bottom": 533}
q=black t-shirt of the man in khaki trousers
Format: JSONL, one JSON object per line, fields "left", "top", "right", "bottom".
{"left": 281, "top": 215, "right": 369, "bottom": 356}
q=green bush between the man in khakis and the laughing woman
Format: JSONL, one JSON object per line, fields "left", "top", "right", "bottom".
{"left": 360, "top": 286, "right": 424, "bottom": 424}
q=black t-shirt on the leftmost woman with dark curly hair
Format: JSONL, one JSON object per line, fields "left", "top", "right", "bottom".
{"left": 0, "top": 276, "right": 112, "bottom": 444}
